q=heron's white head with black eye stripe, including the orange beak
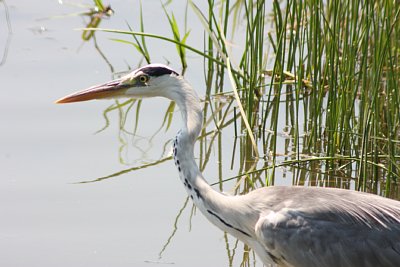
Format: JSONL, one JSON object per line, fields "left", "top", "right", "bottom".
{"left": 56, "top": 64, "right": 183, "bottom": 103}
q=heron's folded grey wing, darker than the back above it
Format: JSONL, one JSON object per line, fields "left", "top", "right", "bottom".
{"left": 255, "top": 208, "right": 400, "bottom": 267}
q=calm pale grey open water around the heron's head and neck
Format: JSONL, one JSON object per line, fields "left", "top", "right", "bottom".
{"left": 0, "top": 0, "right": 256, "bottom": 267}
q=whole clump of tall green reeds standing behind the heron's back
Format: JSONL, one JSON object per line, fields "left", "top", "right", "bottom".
{"left": 195, "top": 0, "right": 400, "bottom": 197}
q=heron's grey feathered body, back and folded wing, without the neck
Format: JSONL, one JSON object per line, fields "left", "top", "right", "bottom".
{"left": 249, "top": 187, "right": 400, "bottom": 267}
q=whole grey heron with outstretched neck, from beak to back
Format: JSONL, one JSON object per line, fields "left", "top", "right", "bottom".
{"left": 57, "top": 64, "right": 400, "bottom": 267}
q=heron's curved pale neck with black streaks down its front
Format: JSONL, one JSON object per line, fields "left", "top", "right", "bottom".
{"left": 174, "top": 81, "right": 250, "bottom": 241}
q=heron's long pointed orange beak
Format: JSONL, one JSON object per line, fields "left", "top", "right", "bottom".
{"left": 56, "top": 79, "right": 131, "bottom": 104}
